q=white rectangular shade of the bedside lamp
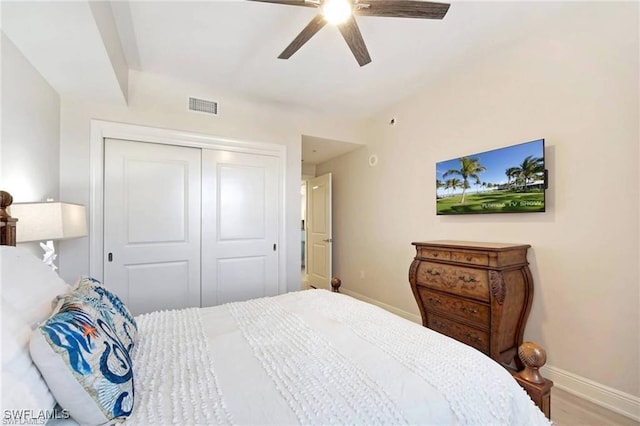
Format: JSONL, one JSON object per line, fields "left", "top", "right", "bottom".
{"left": 10, "top": 201, "right": 87, "bottom": 243}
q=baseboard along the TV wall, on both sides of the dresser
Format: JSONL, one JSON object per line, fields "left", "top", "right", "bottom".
{"left": 340, "top": 288, "right": 640, "bottom": 422}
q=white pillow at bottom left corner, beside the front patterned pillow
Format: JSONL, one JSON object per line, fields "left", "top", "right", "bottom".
{"left": 2, "top": 301, "right": 55, "bottom": 413}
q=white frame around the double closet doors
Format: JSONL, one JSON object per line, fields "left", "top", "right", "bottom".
{"left": 89, "top": 119, "right": 287, "bottom": 294}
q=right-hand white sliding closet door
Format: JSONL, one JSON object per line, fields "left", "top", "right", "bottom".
{"left": 202, "top": 150, "right": 280, "bottom": 306}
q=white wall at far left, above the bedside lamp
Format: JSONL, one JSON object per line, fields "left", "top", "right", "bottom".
{"left": 0, "top": 33, "right": 60, "bottom": 202}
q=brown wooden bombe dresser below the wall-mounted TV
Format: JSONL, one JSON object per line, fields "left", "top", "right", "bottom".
{"left": 409, "top": 241, "right": 533, "bottom": 368}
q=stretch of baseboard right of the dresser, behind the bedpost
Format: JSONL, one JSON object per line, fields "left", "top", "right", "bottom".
{"left": 542, "top": 365, "right": 640, "bottom": 422}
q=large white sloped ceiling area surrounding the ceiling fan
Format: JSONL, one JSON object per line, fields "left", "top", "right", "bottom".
{"left": 113, "top": 1, "right": 558, "bottom": 117}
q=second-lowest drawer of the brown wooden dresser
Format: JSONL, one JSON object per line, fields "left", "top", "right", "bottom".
{"left": 418, "top": 287, "right": 491, "bottom": 329}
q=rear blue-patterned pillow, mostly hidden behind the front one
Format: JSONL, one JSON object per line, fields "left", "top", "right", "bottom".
{"left": 71, "top": 277, "right": 138, "bottom": 352}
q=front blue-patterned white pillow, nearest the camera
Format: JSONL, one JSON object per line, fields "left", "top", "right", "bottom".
{"left": 30, "top": 294, "right": 134, "bottom": 425}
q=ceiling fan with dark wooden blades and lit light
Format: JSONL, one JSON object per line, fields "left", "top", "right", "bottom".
{"left": 249, "top": 0, "right": 450, "bottom": 66}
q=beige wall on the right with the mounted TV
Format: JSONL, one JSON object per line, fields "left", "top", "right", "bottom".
{"left": 318, "top": 2, "right": 640, "bottom": 396}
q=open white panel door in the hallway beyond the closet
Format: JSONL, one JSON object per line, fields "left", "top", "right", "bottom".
{"left": 306, "top": 173, "right": 332, "bottom": 290}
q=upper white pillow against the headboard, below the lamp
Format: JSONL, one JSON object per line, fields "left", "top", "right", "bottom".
{"left": 0, "top": 246, "right": 70, "bottom": 329}
